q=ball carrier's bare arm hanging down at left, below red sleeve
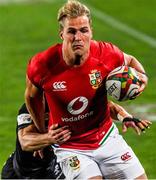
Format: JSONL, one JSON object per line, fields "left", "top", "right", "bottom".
{"left": 25, "top": 77, "right": 46, "bottom": 132}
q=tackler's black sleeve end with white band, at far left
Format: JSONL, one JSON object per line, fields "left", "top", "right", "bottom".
{"left": 17, "top": 104, "right": 33, "bottom": 130}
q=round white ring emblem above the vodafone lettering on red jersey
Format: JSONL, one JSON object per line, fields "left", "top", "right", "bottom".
{"left": 67, "top": 96, "right": 88, "bottom": 115}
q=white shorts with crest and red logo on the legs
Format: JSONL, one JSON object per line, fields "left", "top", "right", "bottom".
{"left": 55, "top": 125, "right": 145, "bottom": 180}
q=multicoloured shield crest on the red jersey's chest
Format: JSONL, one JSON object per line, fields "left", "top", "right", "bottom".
{"left": 89, "top": 70, "right": 102, "bottom": 89}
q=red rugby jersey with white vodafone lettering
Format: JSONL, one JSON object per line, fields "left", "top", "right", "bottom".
{"left": 27, "top": 41, "right": 124, "bottom": 150}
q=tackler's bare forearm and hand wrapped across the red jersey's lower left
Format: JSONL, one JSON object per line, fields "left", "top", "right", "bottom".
{"left": 18, "top": 124, "right": 71, "bottom": 151}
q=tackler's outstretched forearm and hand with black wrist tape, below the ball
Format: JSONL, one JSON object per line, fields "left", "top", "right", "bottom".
{"left": 109, "top": 101, "right": 152, "bottom": 135}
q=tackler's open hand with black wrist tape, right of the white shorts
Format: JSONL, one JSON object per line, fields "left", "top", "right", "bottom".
{"left": 122, "top": 117, "right": 152, "bottom": 135}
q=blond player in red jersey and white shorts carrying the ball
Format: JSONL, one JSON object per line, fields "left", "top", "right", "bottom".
{"left": 25, "top": 0, "right": 149, "bottom": 179}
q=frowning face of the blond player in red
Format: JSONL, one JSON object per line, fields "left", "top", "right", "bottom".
{"left": 60, "top": 15, "right": 92, "bottom": 63}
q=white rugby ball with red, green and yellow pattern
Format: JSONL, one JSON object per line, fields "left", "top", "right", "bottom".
{"left": 106, "top": 66, "right": 141, "bottom": 101}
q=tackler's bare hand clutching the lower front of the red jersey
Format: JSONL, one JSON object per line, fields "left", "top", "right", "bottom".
{"left": 48, "top": 124, "right": 71, "bottom": 144}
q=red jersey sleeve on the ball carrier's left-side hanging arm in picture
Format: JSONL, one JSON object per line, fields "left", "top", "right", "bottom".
{"left": 27, "top": 53, "right": 45, "bottom": 88}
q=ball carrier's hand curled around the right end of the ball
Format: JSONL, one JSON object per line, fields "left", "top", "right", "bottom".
{"left": 137, "top": 71, "right": 148, "bottom": 95}
